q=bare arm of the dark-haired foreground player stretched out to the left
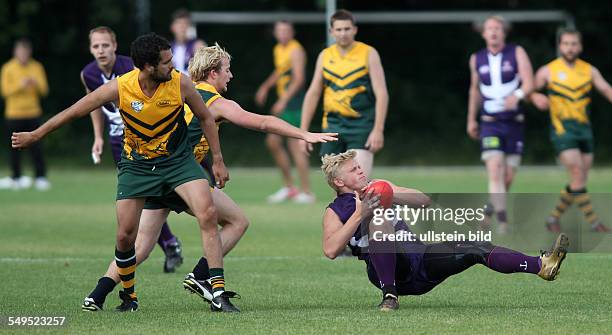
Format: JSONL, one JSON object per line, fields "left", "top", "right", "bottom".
{"left": 12, "top": 79, "right": 119, "bottom": 148}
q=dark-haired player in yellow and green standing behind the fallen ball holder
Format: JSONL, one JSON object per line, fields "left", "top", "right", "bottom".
{"left": 301, "top": 10, "right": 389, "bottom": 175}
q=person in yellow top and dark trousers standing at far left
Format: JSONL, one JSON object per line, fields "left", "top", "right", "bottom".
{"left": 0, "top": 38, "right": 51, "bottom": 191}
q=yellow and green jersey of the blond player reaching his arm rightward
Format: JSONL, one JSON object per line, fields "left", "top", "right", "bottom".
{"left": 185, "top": 83, "right": 221, "bottom": 163}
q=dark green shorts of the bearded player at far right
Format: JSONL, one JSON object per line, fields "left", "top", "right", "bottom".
{"left": 550, "top": 121, "right": 595, "bottom": 155}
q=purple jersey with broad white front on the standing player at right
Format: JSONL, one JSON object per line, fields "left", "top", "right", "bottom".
{"left": 476, "top": 44, "right": 521, "bottom": 120}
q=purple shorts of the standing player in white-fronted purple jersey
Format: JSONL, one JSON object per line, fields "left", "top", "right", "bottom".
{"left": 480, "top": 120, "right": 525, "bottom": 155}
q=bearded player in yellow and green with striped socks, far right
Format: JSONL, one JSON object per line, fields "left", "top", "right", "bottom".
{"left": 531, "top": 29, "right": 612, "bottom": 232}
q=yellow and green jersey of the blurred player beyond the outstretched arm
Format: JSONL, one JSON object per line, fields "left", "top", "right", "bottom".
{"left": 273, "top": 40, "right": 304, "bottom": 110}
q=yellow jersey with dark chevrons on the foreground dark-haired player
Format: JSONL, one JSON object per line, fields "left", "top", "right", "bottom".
{"left": 117, "top": 69, "right": 189, "bottom": 163}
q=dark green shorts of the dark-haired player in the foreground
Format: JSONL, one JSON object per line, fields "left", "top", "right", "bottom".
{"left": 117, "top": 153, "right": 207, "bottom": 200}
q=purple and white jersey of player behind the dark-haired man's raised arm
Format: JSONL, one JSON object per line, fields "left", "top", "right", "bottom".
{"left": 81, "top": 55, "right": 134, "bottom": 137}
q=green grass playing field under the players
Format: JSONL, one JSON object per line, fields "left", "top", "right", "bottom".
{"left": 0, "top": 167, "right": 612, "bottom": 334}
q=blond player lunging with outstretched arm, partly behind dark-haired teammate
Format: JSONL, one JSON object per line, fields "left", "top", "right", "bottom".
{"left": 82, "top": 45, "right": 335, "bottom": 312}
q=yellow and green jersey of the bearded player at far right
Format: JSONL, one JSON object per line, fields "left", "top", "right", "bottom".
{"left": 547, "top": 58, "right": 593, "bottom": 134}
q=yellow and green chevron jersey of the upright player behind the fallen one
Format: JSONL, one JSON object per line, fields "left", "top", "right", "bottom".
{"left": 322, "top": 42, "right": 376, "bottom": 129}
